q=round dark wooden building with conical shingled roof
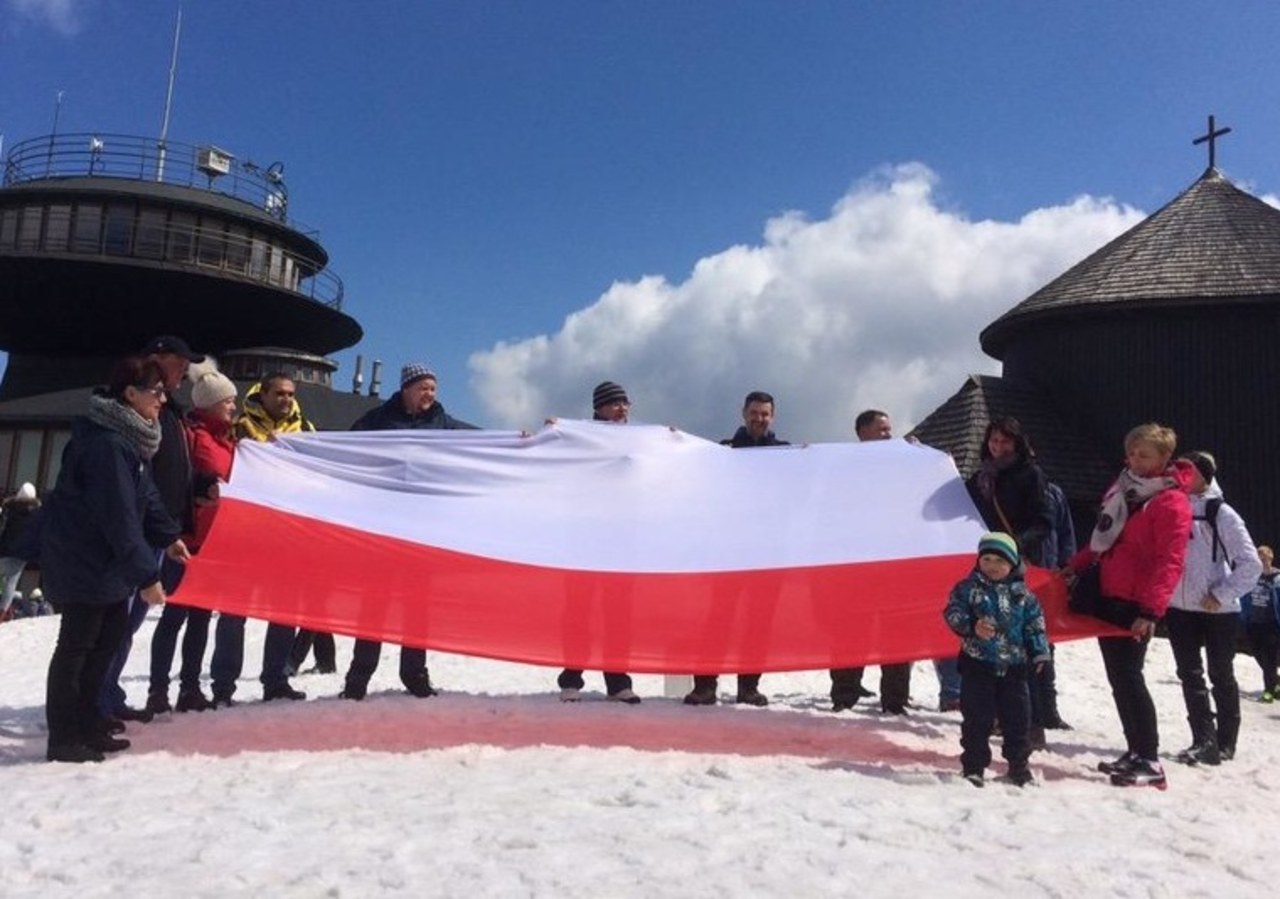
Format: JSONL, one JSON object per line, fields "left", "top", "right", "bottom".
{"left": 914, "top": 165, "right": 1280, "bottom": 543}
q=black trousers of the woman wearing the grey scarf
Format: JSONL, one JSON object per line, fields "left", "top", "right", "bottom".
{"left": 45, "top": 599, "right": 130, "bottom": 747}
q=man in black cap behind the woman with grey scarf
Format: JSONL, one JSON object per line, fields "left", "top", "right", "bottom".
{"left": 97, "top": 334, "right": 205, "bottom": 722}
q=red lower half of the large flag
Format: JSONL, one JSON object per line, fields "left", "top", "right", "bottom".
{"left": 178, "top": 499, "right": 1121, "bottom": 674}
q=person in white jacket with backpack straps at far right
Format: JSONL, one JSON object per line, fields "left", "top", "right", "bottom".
{"left": 1165, "top": 452, "right": 1262, "bottom": 765}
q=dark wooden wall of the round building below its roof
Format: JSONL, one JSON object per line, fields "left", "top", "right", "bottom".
{"left": 1004, "top": 304, "right": 1280, "bottom": 544}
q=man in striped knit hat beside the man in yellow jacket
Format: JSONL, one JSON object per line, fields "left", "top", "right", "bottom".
{"left": 340, "top": 362, "right": 476, "bottom": 699}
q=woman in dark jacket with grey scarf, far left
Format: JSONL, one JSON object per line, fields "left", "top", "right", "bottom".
{"left": 40, "top": 356, "right": 189, "bottom": 762}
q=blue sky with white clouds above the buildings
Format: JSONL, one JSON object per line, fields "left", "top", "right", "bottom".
{"left": 0, "top": 0, "right": 1280, "bottom": 441}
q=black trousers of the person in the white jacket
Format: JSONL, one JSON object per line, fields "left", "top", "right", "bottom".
{"left": 1165, "top": 608, "right": 1240, "bottom": 750}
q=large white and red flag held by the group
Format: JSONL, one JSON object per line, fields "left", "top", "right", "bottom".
{"left": 179, "top": 420, "right": 1103, "bottom": 674}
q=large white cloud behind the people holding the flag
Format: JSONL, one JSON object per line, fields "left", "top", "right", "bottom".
{"left": 470, "top": 164, "right": 1143, "bottom": 442}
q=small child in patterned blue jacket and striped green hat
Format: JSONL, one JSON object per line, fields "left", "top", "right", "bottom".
{"left": 942, "top": 531, "right": 1050, "bottom": 786}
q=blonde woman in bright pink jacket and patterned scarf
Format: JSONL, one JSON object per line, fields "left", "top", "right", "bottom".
{"left": 1066, "top": 424, "right": 1192, "bottom": 789}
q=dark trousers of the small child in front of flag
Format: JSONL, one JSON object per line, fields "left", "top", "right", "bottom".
{"left": 960, "top": 657, "right": 1032, "bottom": 775}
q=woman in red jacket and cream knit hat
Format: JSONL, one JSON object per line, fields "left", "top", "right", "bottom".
{"left": 147, "top": 371, "right": 236, "bottom": 715}
